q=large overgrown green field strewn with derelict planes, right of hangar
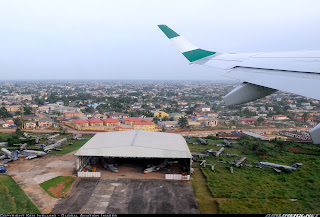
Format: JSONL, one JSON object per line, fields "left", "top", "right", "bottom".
{"left": 189, "top": 139, "right": 320, "bottom": 214}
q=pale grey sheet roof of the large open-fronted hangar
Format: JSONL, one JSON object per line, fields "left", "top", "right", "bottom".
{"left": 75, "top": 130, "right": 192, "bottom": 158}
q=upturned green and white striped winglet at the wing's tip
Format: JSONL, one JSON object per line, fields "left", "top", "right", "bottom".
{"left": 158, "top": 25, "right": 216, "bottom": 63}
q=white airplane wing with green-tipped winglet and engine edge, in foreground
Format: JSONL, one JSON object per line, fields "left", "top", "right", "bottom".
{"left": 158, "top": 25, "right": 320, "bottom": 144}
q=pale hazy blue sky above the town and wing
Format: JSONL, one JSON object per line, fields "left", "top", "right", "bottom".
{"left": 0, "top": 0, "right": 320, "bottom": 80}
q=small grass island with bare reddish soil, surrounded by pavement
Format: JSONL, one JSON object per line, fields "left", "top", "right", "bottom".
{"left": 40, "top": 176, "right": 76, "bottom": 198}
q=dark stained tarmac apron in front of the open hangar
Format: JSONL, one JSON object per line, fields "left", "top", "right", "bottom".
{"left": 52, "top": 178, "right": 199, "bottom": 214}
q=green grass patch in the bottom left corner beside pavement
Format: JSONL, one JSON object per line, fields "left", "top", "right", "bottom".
{"left": 0, "top": 175, "right": 41, "bottom": 214}
